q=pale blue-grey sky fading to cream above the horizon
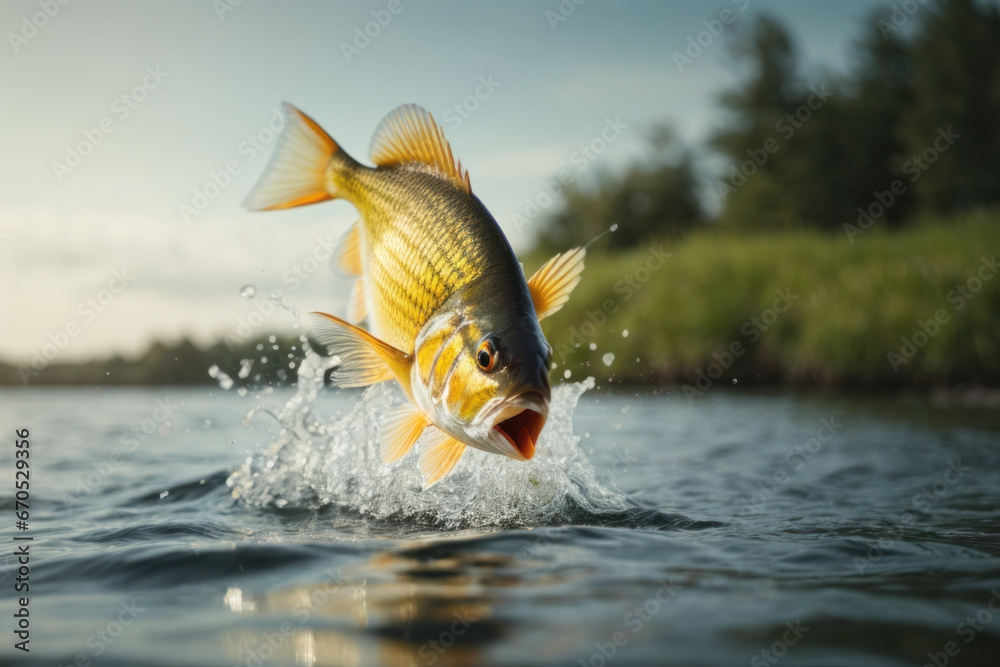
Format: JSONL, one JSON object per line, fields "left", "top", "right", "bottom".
{"left": 0, "top": 0, "right": 883, "bottom": 363}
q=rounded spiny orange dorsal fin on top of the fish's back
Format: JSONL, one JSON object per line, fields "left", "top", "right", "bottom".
{"left": 371, "top": 104, "right": 472, "bottom": 193}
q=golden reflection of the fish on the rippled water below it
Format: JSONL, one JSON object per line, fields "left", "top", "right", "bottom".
{"left": 223, "top": 542, "right": 556, "bottom": 667}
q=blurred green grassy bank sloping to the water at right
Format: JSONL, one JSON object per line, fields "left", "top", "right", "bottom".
{"left": 529, "top": 212, "right": 1000, "bottom": 387}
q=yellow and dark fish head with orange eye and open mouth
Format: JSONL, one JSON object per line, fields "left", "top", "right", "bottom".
{"left": 411, "top": 311, "right": 552, "bottom": 461}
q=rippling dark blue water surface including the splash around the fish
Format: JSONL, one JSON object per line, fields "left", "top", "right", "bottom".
{"left": 0, "top": 360, "right": 1000, "bottom": 667}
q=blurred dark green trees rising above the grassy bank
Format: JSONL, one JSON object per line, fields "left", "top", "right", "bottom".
{"left": 538, "top": 0, "right": 1000, "bottom": 252}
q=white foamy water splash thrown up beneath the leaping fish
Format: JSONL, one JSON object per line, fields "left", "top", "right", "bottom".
{"left": 227, "top": 347, "right": 629, "bottom": 528}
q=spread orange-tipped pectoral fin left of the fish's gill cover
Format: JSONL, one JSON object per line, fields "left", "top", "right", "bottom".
{"left": 310, "top": 313, "right": 413, "bottom": 394}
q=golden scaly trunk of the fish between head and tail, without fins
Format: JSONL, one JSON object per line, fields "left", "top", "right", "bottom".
{"left": 335, "top": 166, "right": 534, "bottom": 353}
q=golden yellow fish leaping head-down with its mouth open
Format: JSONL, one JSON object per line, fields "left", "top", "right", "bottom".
{"left": 244, "top": 103, "right": 586, "bottom": 488}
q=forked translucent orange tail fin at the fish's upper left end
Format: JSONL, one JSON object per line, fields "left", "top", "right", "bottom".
{"left": 243, "top": 102, "right": 340, "bottom": 211}
